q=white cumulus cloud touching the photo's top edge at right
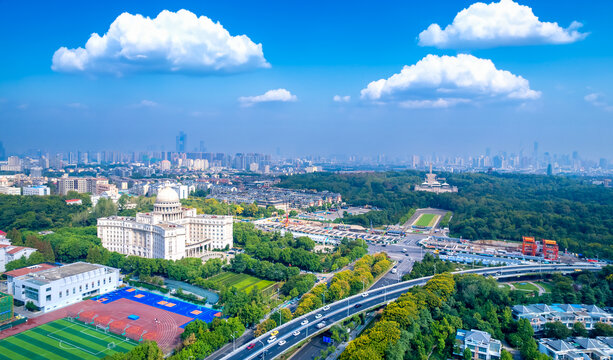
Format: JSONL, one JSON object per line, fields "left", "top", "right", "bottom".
{"left": 419, "top": 0, "right": 588, "bottom": 48}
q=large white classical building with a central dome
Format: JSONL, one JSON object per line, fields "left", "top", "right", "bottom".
{"left": 98, "top": 187, "right": 233, "bottom": 260}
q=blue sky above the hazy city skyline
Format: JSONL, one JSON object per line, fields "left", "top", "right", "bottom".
{"left": 0, "top": 0, "right": 613, "bottom": 158}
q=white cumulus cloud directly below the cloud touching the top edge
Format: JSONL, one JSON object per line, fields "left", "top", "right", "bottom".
{"left": 361, "top": 54, "right": 541, "bottom": 108}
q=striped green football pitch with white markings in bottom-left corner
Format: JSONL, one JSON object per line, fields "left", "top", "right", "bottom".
{"left": 0, "top": 319, "right": 137, "bottom": 360}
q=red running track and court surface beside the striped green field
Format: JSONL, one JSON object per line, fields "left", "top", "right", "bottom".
{"left": 0, "top": 299, "right": 192, "bottom": 352}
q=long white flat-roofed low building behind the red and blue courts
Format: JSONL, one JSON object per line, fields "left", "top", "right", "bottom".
{"left": 7, "top": 262, "right": 119, "bottom": 312}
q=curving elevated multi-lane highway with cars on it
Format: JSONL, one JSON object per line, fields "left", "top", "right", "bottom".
{"left": 215, "top": 264, "right": 600, "bottom": 360}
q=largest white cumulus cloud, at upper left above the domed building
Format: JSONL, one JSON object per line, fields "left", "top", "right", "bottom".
{"left": 51, "top": 10, "right": 270, "bottom": 75}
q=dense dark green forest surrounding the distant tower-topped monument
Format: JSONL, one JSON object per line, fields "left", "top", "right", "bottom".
{"left": 279, "top": 171, "right": 613, "bottom": 259}
